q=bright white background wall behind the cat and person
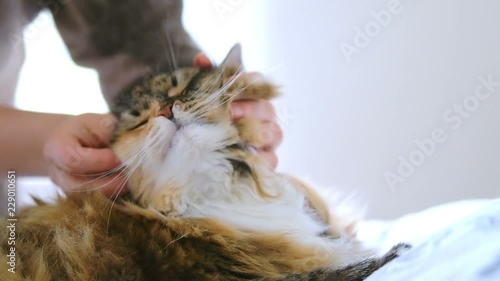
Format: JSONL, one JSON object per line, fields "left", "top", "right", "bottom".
{"left": 13, "top": 0, "right": 500, "bottom": 218}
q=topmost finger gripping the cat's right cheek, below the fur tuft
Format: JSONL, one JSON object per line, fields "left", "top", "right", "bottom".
{"left": 231, "top": 99, "right": 276, "bottom": 121}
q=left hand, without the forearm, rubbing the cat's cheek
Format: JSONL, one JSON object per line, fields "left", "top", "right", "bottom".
{"left": 44, "top": 114, "right": 127, "bottom": 196}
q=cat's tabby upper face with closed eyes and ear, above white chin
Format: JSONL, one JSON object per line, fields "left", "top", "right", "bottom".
{"left": 112, "top": 45, "right": 242, "bottom": 140}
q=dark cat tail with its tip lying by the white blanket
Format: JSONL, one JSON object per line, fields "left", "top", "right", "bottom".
{"left": 259, "top": 243, "right": 411, "bottom": 281}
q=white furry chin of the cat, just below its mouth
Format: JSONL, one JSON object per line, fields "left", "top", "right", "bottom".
{"left": 141, "top": 120, "right": 231, "bottom": 185}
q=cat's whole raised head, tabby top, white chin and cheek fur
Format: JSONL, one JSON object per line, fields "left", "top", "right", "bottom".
{"left": 112, "top": 45, "right": 276, "bottom": 210}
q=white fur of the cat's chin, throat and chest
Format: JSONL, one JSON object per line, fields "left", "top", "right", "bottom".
{"left": 143, "top": 121, "right": 326, "bottom": 238}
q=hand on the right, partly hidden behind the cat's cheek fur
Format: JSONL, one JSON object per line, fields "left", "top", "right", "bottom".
{"left": 194, "top": 54, "right": 283, "bottom": 169}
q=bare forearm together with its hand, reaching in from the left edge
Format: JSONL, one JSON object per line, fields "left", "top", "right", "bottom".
{"left": 0, "top": 106, "right": 123, "bottom": 194}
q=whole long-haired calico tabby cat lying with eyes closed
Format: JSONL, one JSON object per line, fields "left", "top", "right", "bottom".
{"left": 0, "top": 45, "right": 409, "bottom": 281}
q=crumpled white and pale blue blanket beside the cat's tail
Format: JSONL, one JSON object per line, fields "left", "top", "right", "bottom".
{"left": 361, "top": 199, "right": 500, "bottom": 281}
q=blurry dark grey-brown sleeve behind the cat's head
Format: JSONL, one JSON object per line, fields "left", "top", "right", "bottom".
{"left": 47, "top": 0, "right": 200, "bottom": 104}
